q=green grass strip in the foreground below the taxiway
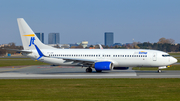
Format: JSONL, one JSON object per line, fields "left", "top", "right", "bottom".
{"left": 0, "top": 79, "right": 180, "bottom": 101}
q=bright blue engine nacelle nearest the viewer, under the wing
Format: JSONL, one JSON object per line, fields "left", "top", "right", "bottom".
{"left": 94, "top": 61, "right": 114, "bottom": 70}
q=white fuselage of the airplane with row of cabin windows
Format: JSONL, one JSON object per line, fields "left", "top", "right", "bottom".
{"left": 23, "top": 49, "right": 177, "bottom": 67}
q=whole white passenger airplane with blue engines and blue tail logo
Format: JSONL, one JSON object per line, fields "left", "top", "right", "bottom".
{"left": 17, "top": 18, "right": 177, "bottom": 73}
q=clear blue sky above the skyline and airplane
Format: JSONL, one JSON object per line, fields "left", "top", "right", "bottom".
{"left": 0, "top": 0, "right": 180, "bottom": 45}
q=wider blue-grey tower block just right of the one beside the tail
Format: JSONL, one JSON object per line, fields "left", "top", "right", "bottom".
{"left": 48, "top": 33, "right": 60, "bottom": 44}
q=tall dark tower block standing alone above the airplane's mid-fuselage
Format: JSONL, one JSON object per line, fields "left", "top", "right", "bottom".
{"left": 104, "top": 32, "right": 114, "bottom": 46}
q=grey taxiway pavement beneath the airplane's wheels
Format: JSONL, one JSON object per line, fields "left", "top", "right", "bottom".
{"left": 0, "top": 65, "right": 180, "bottom": 79}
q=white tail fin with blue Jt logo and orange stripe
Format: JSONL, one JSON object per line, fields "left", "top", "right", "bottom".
{"left": 17, "top": 18, "right": 54, "bottom": 50}
